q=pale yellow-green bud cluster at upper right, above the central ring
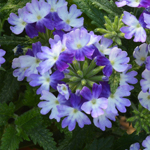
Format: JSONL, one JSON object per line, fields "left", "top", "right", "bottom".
{"left": 95, "top": 15, "right": 124, "bottom": 45}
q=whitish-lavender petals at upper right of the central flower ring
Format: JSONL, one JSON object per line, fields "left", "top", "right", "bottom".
{"left": 109, "top": 47, "right": 130, "bottom": 72}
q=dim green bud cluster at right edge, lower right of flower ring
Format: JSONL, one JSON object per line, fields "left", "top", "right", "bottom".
{"left": 127, "top": 104, "right": 150, "bottom": 134}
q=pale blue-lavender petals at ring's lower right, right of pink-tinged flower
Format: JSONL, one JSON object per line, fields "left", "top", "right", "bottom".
{"left": 106, "top": 85, "right": 131, "bottom": 114}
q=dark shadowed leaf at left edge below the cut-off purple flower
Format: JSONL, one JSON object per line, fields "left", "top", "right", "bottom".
{"left": 0, "top": 71, "right": 19, "bottom": 103}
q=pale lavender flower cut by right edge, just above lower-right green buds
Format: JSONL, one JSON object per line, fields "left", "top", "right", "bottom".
{"left": 138, "top": 91, "right": 150, "bottom": 110}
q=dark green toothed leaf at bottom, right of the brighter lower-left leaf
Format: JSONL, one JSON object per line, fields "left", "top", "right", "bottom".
{"left": 28, "top": 124, "right": 57, "bottom": 150}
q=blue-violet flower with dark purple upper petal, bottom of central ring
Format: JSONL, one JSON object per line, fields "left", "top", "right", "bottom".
{"left": 57, "top": 94, "right": 91, "bottom": 131}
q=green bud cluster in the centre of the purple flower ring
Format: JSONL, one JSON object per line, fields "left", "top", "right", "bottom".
{"left": 64, "top": 59, "right": 104, "bottom": 92}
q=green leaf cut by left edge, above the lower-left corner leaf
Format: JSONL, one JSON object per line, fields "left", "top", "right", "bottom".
{"left": 0, "top": 102, "right": 15, "bottom": 126}
